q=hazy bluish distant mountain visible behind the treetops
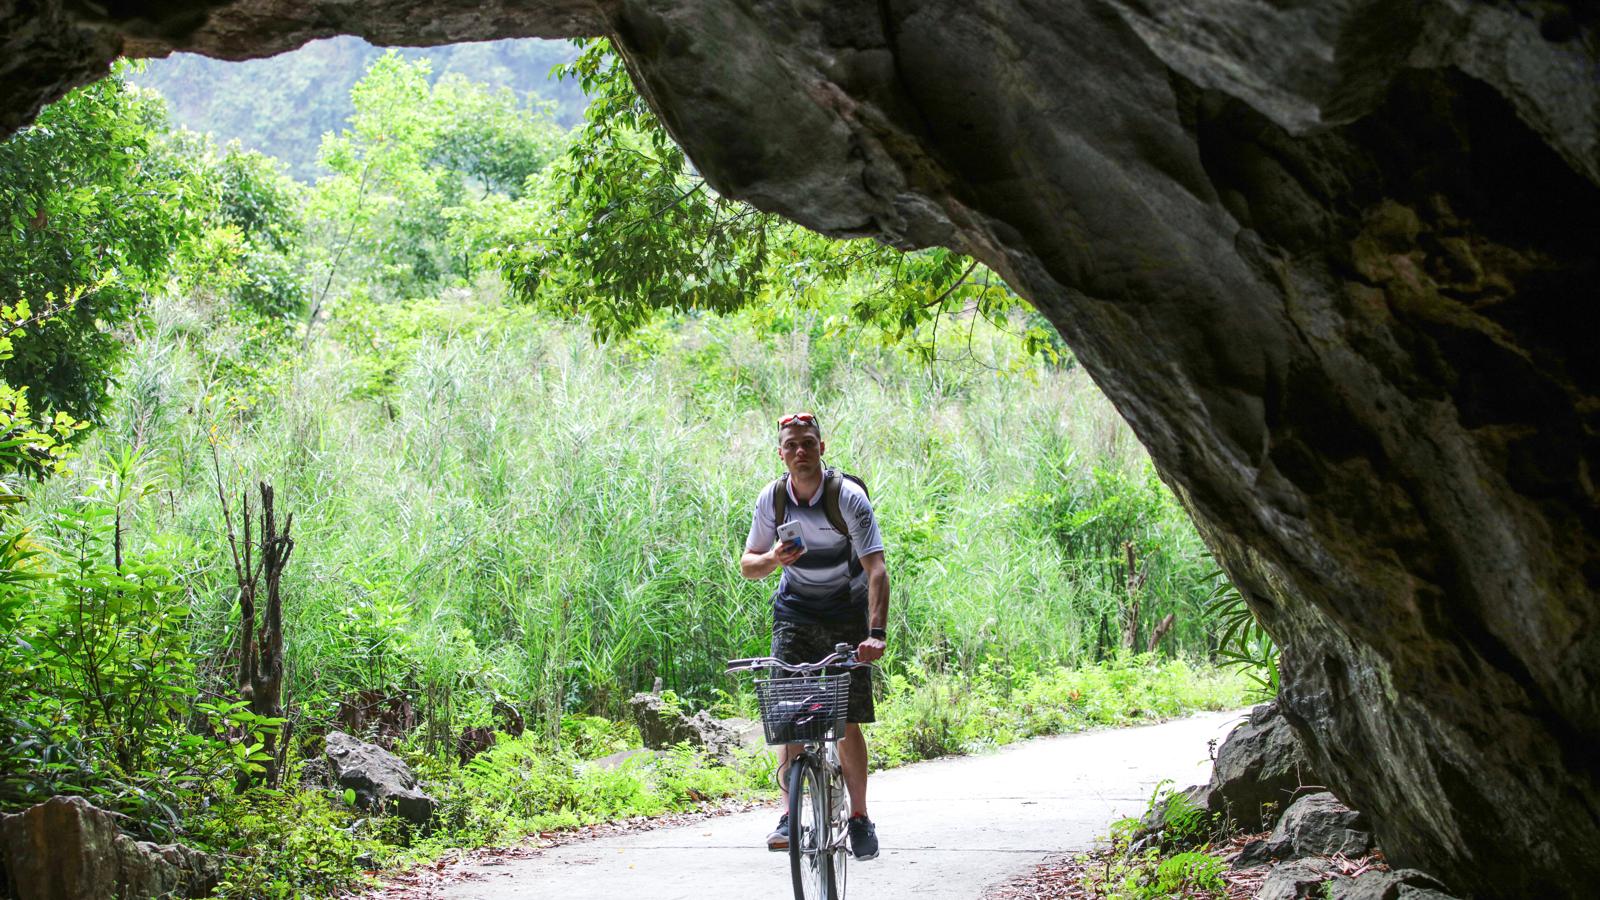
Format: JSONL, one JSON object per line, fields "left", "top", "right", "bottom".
{"left": 130, "top": 37, "right": 586, "bottom": 181}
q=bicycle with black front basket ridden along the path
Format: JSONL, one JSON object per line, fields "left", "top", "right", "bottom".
{"left": 726, "top": 644, "right": 869, "bottom": 900}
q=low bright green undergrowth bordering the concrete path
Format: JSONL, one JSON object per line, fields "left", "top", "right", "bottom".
{"left": 198, "top": 655, "right": 1248, "bottom": 897}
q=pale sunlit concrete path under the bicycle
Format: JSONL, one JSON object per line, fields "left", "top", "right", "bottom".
{"left": 406, "top": 713, "right": 1243, "bottom": 900}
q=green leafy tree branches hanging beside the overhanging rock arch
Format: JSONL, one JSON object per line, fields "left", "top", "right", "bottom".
{"left": 491, "top": 40, "right": 1058, "bottom": 362}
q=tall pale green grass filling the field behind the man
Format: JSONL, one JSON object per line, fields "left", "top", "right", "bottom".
{"left": 42, "top": 286, "right": 1211, "bottom": 735}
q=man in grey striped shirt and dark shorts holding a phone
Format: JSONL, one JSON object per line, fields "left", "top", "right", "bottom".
{"left": 739, "top": 413, "right": 890, "bottom": 860}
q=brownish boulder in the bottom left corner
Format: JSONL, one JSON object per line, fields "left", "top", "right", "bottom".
{"left": 0, "top": 798, "right": 222, "bottom": 900}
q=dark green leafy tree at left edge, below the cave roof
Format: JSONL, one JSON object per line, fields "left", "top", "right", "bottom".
{"left": 0, "top": 69, "right": 210, "bottom": 421}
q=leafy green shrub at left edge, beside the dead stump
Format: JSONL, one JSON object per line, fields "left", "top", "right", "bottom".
{"left": 0, "top": 483, "right": 277, "bottom": 838}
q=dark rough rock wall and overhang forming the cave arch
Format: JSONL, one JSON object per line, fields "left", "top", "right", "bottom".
{"left": 0, "top": 0, "right": 1600, "bottom": 897}
